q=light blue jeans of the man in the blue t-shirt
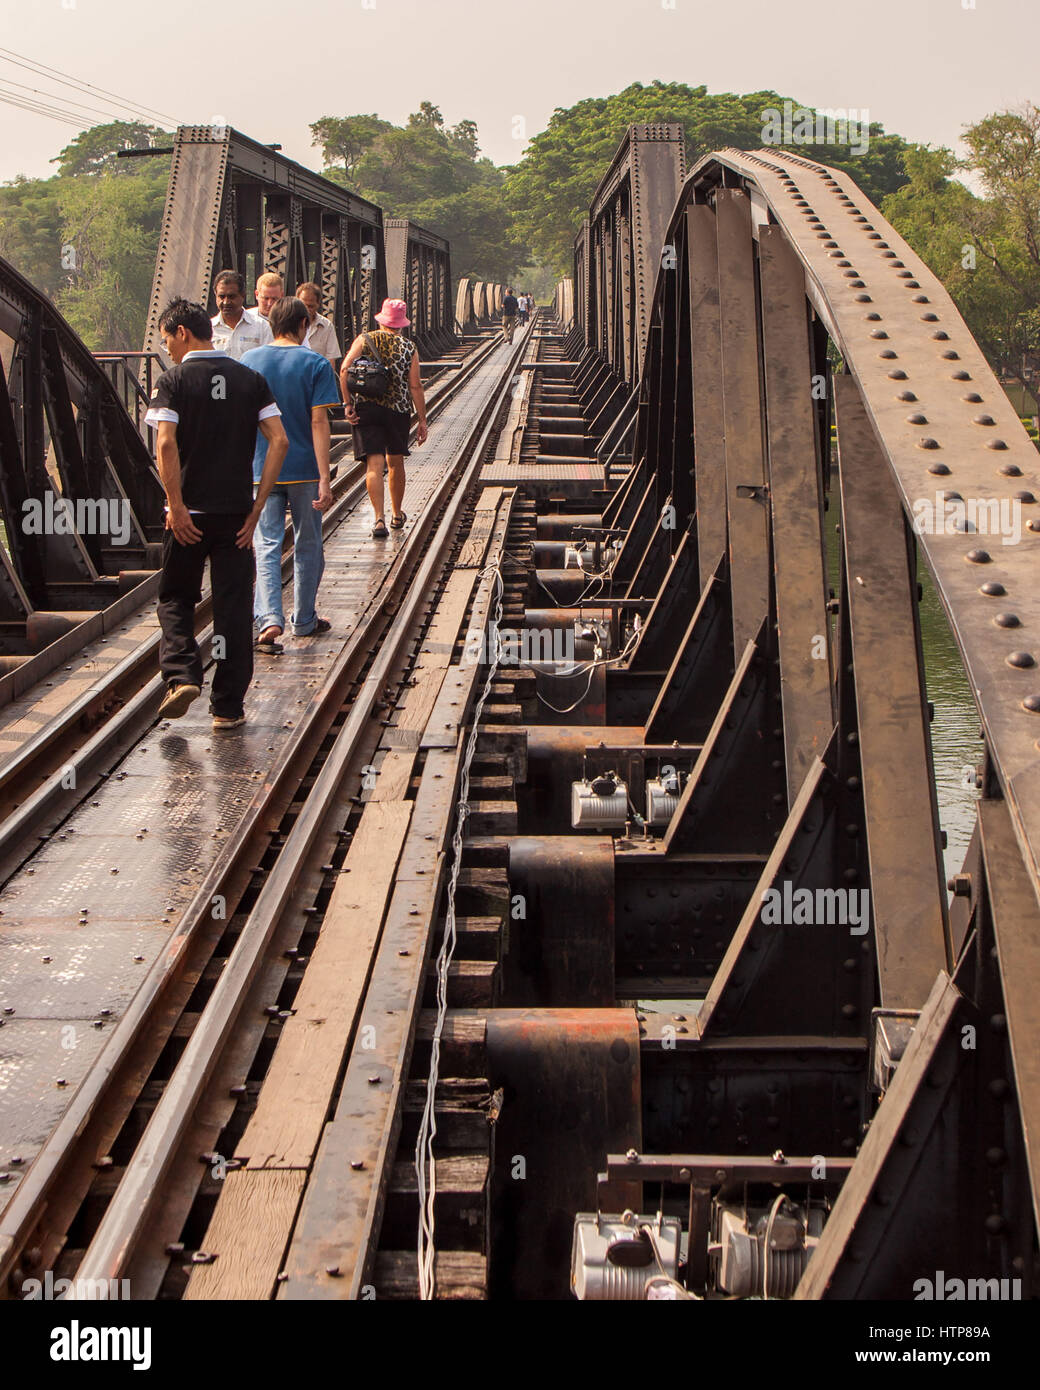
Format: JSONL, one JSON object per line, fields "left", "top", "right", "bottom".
{"left": 253, "top": 482, "right": 325, "bottom": 637}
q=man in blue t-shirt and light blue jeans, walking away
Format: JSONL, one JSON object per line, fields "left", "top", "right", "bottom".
{"left": 242, "top": 296, "right": 339, "bottom": 642}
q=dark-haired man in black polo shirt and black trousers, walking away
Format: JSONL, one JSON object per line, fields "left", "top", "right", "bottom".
{"left": 145, "top": 299, "right": 289, "bottom": 730}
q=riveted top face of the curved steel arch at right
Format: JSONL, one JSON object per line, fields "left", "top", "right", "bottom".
{"left": 690, "top": 150, "right": 1040, "bottom": 911}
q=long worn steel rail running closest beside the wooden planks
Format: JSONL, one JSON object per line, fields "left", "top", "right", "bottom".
{"left": 42, "top": 328, "right": 526, "bottom": 1279}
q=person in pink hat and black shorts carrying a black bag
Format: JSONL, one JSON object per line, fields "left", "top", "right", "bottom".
{"left": 339, "top": 299, "right": 430, "bottom": 541}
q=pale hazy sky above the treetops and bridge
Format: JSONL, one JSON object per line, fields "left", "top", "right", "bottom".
{"left": 0, "top": 0, "right": 1040, "bottom": 181}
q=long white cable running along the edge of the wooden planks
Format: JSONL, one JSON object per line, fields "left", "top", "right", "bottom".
{"left": 416, "top": 560, "right": 505, "bottom": 1301}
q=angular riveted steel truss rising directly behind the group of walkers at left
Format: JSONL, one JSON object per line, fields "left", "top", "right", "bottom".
{"left": 145, "top": 125, "right": 387, "bottom": 352}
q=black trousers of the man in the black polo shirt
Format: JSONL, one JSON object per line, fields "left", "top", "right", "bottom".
{"left": 159, "top": 513, "right": 256, "bottom": 719}
